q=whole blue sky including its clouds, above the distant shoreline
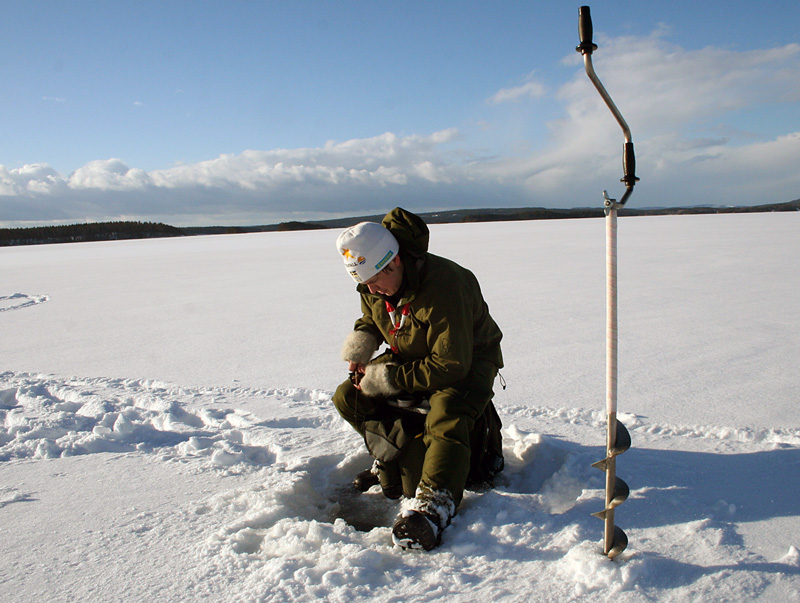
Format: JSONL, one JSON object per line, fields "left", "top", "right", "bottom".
{"left": 0, "top": 0, "right": 800, "bottom": 226}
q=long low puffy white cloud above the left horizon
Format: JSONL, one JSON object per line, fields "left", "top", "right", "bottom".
{"left": 0, "top": 129, "right": 482, "bottom": 224}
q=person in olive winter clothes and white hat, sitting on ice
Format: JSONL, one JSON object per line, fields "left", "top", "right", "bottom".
{"left": 333, "top": 208, "right": 503, "bottom": 550}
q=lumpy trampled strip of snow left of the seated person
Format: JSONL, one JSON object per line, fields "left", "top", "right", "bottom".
{"left": 0, "top": 373, "right": 333, "bottom": 468}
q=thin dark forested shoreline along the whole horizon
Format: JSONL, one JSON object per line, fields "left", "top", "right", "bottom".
{"left": 0, "top": 199, "right": 800, "bottom": 247}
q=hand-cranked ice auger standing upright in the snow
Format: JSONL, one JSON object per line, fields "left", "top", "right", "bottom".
{"left": 575, "top": 6, "right": 639, "bottom": 558}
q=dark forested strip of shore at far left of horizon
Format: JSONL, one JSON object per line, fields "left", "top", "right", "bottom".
{"left": 0, "top": 222, "right": 184, "bottom": 246}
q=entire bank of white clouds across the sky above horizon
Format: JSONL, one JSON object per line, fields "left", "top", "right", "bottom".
{"left": 0, "top": 33, "right": 800, "bottom": 226}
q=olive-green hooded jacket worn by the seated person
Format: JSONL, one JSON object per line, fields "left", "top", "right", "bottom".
{"left": 355, "top": 207, "right": 503, "bottom": 392}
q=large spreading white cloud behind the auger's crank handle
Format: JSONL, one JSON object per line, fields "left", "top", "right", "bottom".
{"left": 482, "top": 34, "right": 800, "bottom": 205}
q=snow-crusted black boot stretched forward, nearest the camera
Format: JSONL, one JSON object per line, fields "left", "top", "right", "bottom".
{"left": 392, "top": 484, "right": 456, "bottom": 551}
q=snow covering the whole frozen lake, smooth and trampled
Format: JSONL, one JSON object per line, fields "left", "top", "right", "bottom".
{"left": 0, "top": 213, "right": 800, "bottom": 603}
